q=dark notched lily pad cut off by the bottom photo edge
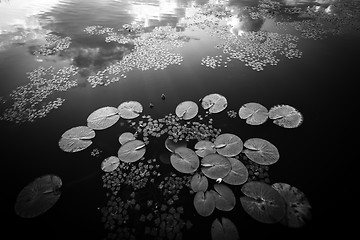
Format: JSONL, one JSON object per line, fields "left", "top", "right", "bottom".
{"left": 211, "top": 217, "right": 240, "bottom": 240}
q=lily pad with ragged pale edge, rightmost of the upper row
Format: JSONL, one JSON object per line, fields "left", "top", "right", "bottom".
{"left": 269, "top": 105, "right": 303, "bottom": 128}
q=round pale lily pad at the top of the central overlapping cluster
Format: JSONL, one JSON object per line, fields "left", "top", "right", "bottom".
{"left": 214, "top": 133, "right": 243, "bottom": 157}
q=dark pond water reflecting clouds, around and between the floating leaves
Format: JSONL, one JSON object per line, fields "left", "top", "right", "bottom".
{"left": 0, "top": 0, "right": 360, "bottom": 239}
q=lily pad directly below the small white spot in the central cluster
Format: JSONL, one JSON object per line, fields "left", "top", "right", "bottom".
{"left": 211, "top": 184, "right": 236, "bottom": 211}
